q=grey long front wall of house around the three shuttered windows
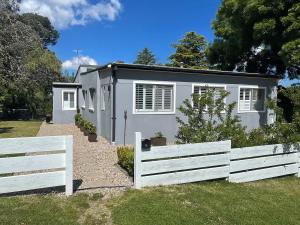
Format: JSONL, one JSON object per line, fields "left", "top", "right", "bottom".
{"left": 116, "top": 69, "right": 277, "bottom": 144}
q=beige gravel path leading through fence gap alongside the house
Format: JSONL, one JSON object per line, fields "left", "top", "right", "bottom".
{"left": 37, "top": 123, "right": 132, "bottom": 194}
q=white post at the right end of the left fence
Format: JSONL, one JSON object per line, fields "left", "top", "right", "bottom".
{"left": 65, "top": 135, "right": 73, "bottom": 196}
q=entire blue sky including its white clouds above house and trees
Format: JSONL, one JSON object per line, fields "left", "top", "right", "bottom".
{"left": 21, "top": 0, "right": 298, "bottom": 85}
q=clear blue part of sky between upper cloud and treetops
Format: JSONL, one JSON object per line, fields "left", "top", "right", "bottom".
{"left": 53, "top": 0, "right": 220, "bottom": 64}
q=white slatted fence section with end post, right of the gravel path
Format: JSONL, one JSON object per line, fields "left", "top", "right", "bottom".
{"left": 134, "top": 132, "right": 231, "bottom": 188}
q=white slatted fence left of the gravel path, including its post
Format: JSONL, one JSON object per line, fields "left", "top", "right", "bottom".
{"left": 0, "top": 136, "right": 73, "bottom": 195}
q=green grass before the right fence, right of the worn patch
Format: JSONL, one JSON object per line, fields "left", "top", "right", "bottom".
{"left": 110, "top": 177, "right": 300, "bottom": 225}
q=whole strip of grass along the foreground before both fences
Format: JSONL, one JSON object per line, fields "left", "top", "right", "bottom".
{"left": 0, "top": 177, "right": 300, "bottom": 225}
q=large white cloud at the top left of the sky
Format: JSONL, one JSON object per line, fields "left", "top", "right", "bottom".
{"left": 20, "top": 0, "right": 122, "bottom": 29}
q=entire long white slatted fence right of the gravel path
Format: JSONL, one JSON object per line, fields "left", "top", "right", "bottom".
{"left": 134, "top": 132, "right": 300, "bottom": 188}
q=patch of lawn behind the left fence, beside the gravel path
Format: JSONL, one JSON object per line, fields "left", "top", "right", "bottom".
{"left": 0, "top": 121, "right": 42, "bottom": 138}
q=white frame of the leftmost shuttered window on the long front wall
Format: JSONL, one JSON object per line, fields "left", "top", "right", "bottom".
{"left": 132, "top": 80, "right": 176, "bottom": 115}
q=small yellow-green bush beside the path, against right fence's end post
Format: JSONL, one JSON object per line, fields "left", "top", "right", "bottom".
{"left": 117, "top": 146, "right": 134, "bottom": 176}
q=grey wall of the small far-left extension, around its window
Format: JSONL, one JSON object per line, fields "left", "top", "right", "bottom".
{"left": 52, "top": 87, "right": 77, "bottom": 124}
